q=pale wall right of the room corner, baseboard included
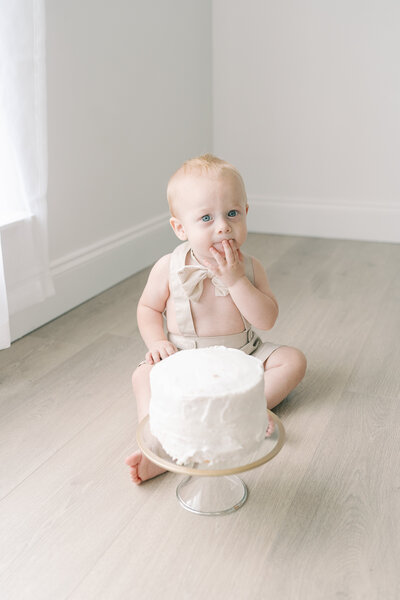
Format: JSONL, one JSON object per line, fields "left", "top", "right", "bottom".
{"left": 213, "top": 0, "right": 400, "bottom": 242}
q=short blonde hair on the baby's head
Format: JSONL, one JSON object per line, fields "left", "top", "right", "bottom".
{"left": 167, "top": 154, "right": 247, "bottom": 216}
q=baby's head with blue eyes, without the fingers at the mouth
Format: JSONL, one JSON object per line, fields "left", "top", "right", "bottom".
{"left": 167, "top": 154, "right": 248, "bottom": 260}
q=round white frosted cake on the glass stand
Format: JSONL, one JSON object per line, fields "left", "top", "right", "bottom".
{"left": 149, "top": 346, "right": 268, "bottom": 466}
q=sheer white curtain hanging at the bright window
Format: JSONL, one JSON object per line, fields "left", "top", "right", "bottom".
{"left": 0, "top": 0, "right": 54, "bottom": 349}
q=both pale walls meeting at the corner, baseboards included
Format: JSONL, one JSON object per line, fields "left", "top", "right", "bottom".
{"left": 11, "top": 0, "right": 400, "bottom": 339}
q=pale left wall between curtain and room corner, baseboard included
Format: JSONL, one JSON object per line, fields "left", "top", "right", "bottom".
{"left": 11, "top": 0, "right": 212, "bottom": 339}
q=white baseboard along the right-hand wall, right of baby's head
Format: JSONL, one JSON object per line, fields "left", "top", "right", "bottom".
{"left": 248, "top": 195, "right": 400, "bottom": 243}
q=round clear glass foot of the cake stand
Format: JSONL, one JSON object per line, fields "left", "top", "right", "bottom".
{"left": 176, "top": 475, "right": 248, "bottom": 516}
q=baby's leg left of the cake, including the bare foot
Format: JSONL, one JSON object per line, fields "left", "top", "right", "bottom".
{"left": 125, "top": 364, "right": 165, "bottom": 485}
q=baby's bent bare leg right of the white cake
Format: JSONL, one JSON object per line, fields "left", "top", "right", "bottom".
{"left": 264, "top": 346, "right": 307, "bottom": 410}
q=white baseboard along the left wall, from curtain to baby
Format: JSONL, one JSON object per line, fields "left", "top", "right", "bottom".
{"left": 10, "top": 213, "right": 178, "bottom": 341}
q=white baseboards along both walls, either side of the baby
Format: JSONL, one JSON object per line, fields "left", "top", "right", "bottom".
{"left": 10, "top": 196, "right": 400, "bottom": 341}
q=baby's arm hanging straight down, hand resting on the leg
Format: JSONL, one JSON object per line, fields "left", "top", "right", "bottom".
{"left": 137, "top": 254, "right": 177, "bottom": 365}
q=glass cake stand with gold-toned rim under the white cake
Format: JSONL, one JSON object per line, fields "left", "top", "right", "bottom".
{"left": 137, "top": 410, "right": 285, "bottom": 516}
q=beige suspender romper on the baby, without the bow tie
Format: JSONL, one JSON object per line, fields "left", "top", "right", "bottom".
{"left": 162, "top": 242, "right": 280, "bottom": 362}
